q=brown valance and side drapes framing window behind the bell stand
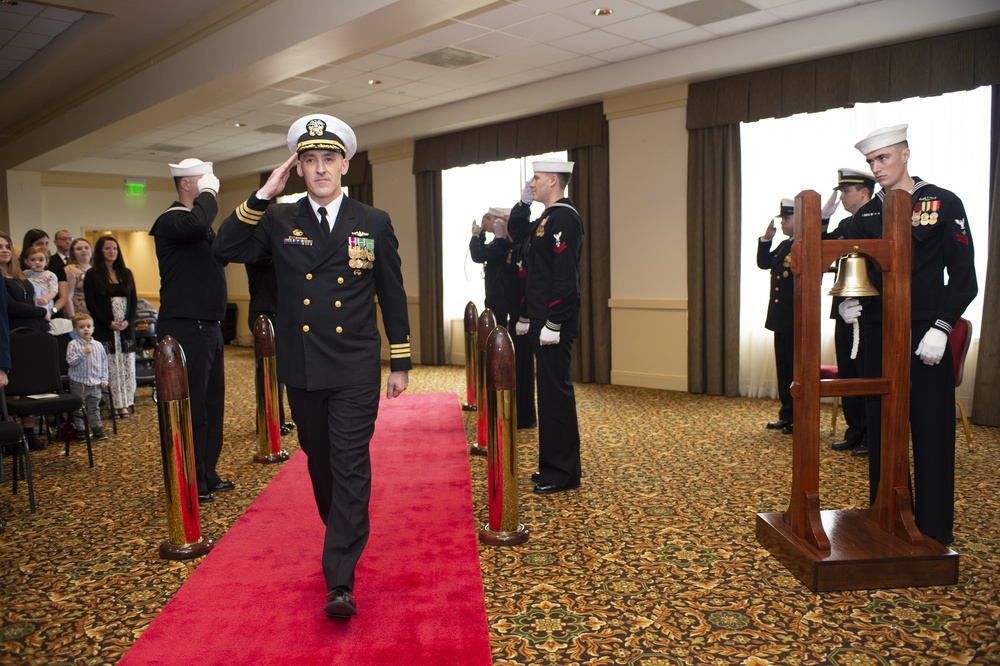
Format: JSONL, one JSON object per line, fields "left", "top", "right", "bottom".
{"left": 687, "top": 25, "right": 1000, "bottom": 416}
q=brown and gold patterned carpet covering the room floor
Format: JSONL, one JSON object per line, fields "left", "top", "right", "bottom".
{"left": 0, "top": 347, "right": 1000, "bottom": 666}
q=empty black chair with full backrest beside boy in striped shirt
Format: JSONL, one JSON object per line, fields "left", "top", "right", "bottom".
{"left": 7, "top": 328, "right": 94, "bottom": 467}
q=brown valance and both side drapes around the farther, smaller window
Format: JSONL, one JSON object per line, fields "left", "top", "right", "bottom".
{"left": 413, "top": 104, "right": 611, "bottom": 383}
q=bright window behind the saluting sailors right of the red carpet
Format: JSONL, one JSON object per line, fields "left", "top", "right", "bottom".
{"left": 441, "top": 151, "right": 567, "bottom": 358}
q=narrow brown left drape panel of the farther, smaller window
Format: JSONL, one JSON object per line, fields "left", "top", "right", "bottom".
{"left": 414, "top": 171, "right": 447, "bottom": 365}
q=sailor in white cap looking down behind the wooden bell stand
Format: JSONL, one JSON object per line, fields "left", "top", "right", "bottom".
{"left": 840, "top": 125, "right": 979, "bottom": 545}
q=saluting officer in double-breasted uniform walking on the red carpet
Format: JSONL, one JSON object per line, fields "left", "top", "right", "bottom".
{"left": 215, "top": 114, "right": 412, "bottom": 617}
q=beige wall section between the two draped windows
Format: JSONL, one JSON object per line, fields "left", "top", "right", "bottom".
{"left": 604, "top": 86, "right": 687, "bottom": 391}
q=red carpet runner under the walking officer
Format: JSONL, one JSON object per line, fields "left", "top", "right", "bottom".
{"left": 120, "top": 393, "right": 491, "bottom": 666}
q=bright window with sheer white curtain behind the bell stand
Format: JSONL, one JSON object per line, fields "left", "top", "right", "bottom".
{"left": 740, "top": 86, "right": 991, "bottom": 400}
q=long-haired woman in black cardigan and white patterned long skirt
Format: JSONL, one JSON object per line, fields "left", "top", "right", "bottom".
{"left": 83, "top": 236, "right": 138, "bottom": 418}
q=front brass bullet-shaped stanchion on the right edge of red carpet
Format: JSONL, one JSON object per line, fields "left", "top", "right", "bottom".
{"left": 479, "top": 326, "right": 528, "bottom": 546}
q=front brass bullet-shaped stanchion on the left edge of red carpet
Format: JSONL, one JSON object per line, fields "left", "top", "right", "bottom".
{"left": 154, "top": 335, "right": 215, "bottom": 560}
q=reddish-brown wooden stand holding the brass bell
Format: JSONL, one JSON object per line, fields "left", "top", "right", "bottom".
{"left": 756, "top": 190, "right": 958, "bottom": 592}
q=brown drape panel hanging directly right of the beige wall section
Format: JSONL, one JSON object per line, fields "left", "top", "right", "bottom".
{"left": 687, "top": 124, "right": 742, "bottom": 396}
